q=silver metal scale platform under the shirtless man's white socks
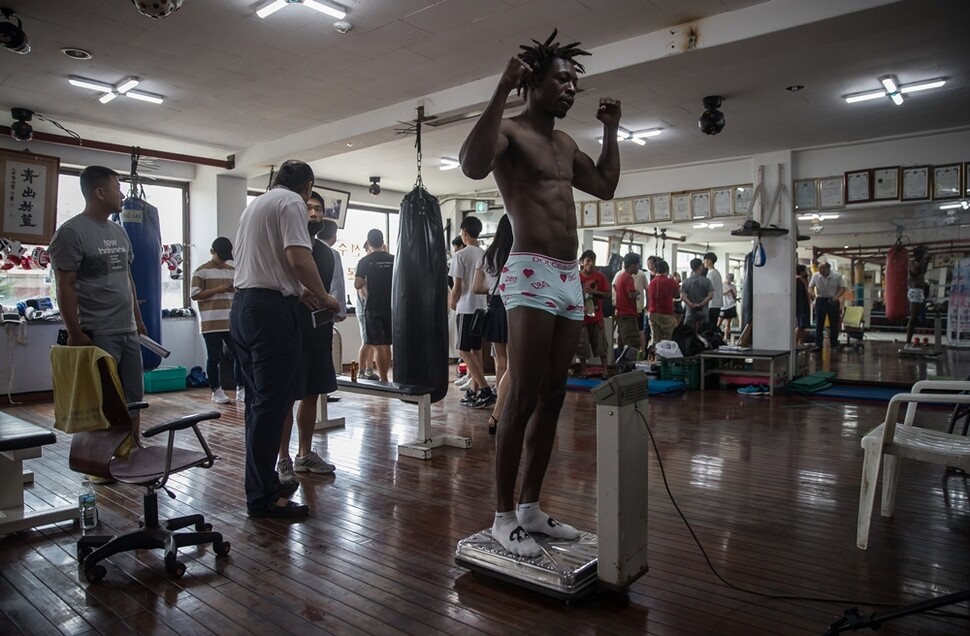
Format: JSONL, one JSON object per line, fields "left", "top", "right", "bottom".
{"left": 455, "top": 528, "right": 597, "bottom": 601}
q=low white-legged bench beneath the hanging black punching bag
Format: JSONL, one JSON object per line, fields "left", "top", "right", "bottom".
{"left": 314, "top": 375, "right": 472, "bottom": 459}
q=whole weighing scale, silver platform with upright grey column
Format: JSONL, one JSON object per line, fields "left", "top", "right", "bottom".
{"left": 455, "top": 371, "right": 649, "bottom": 602}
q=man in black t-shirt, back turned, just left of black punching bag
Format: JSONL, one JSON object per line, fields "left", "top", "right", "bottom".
{"left": 354, "top": 229, "right": 394, "bottom": 382}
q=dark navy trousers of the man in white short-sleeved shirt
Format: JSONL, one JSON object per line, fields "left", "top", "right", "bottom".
{"left": 229, "top": 289, "right": 301, "bottom": 509}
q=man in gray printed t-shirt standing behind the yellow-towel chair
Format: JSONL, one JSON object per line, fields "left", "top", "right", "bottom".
{"left": 49, "top": 166, "right": 146, "bottom": 443}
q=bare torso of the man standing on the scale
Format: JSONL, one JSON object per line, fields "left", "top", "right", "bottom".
{"left": 494, "top": 117, "right": 579, "bottom": 261}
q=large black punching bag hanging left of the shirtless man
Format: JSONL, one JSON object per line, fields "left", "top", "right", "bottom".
{"left": 391, "top": 186, "right": 448, "bottom": 402}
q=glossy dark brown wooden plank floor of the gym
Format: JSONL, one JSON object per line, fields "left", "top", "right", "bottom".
{"left": 0, "top": 362, "right": 970, "bottom": 636}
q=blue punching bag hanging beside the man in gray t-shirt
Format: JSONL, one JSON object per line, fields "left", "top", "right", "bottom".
{"left": 121, "top": 196, "right": 162, "bottom": 371}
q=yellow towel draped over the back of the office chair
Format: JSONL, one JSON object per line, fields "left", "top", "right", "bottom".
{"left": 51, "top": 345, "right": 124, "bottom": 433}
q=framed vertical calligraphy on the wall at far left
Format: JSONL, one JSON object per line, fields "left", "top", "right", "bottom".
{"left": 0, "top": 150, "right": 61, "bottom": 245}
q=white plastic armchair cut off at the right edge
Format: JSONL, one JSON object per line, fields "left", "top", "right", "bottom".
{"left": 856, "top": 380, "right": 970, "bottom": 550}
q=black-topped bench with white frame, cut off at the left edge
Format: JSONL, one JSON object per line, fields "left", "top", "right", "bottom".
{"left": 0, "top": 412, "right": 78, "bottom": 535}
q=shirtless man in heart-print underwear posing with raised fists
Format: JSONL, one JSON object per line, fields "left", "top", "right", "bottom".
{"left": 460, "top": 31, "right": 620, "bottom": 557}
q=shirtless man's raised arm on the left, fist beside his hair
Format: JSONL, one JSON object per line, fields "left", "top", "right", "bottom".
{"left": 458, "top": 57, "right": 532, "bottom": 179}
